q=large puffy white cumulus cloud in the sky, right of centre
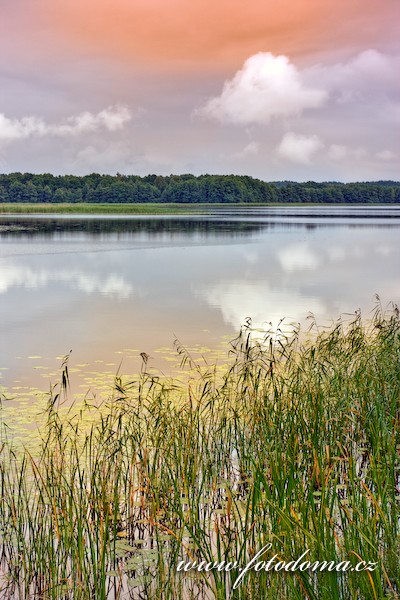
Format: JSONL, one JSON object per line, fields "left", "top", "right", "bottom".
{"left": 196, "top": 52, "right": 327, "bottom": 125}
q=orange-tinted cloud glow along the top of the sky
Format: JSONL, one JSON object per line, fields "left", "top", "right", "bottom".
{"left": 46, "top": 0, "right": 400, "bottom": 69}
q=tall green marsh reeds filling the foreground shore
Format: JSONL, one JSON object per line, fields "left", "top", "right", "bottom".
{"left": 0, "top": 307, "right": 400, "bottom": 600}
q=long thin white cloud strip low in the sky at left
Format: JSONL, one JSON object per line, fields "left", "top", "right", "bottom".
{"left": 0, "top": 105, "right": 132, "bottom": 141}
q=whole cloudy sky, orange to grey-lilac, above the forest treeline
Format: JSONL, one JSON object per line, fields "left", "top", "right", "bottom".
{"left": 0, "top": 0, "right": 400, "bottom": 181}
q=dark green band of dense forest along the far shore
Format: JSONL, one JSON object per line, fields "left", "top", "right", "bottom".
{"left": 0, "top": 173, "right": 400, "bottom": 204}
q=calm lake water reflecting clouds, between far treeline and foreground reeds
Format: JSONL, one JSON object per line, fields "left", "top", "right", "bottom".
{"left": 0, "top": 206, "right": 400, "bottom": 406}
